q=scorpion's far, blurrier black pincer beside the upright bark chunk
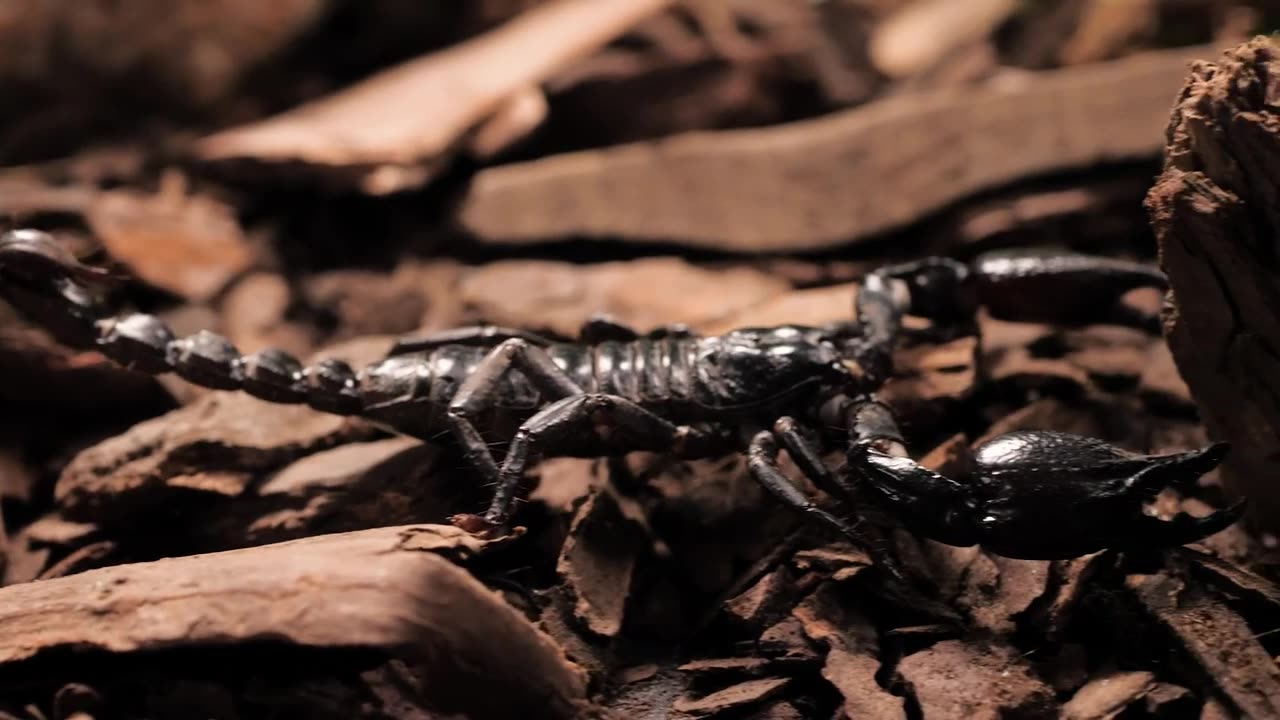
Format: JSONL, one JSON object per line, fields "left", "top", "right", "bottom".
{"left": 973, "top": 251, "right": 1167, "bottom": 334}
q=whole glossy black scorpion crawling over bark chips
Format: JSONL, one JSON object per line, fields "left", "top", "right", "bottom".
{"left": 0, "top": 229, "right": 1242, "bottom": 564}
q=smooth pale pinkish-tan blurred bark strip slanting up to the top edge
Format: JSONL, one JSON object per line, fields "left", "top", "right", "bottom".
{"left": 196, "top": 0, "right": 672, "bottom": 195}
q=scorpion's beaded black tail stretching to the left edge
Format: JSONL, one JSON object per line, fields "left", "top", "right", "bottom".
{"left": 0, "top": 229, "right": 361, "bottom": 415}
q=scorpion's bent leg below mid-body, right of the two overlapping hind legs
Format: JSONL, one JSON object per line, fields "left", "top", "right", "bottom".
{"left": 483, "top": 392, "right": 713, "bottom": 528}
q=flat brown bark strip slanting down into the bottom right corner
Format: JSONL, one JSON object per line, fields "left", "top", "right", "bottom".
{"left": 1125, "top": 573, "right": 1280, "bottom": 717}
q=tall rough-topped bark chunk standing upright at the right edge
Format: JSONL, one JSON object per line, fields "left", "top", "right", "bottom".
{"left": 1147, "top": 37, "right": 1280, "bottom": 530}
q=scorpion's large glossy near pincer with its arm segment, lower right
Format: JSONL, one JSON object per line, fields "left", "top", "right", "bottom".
{"left": 851, "top": 430, "right": 1244, "bottom": 560}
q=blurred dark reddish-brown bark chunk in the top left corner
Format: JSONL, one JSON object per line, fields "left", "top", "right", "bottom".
{"left": 0, "top": 0, "right": 333, "bottom": 165}
